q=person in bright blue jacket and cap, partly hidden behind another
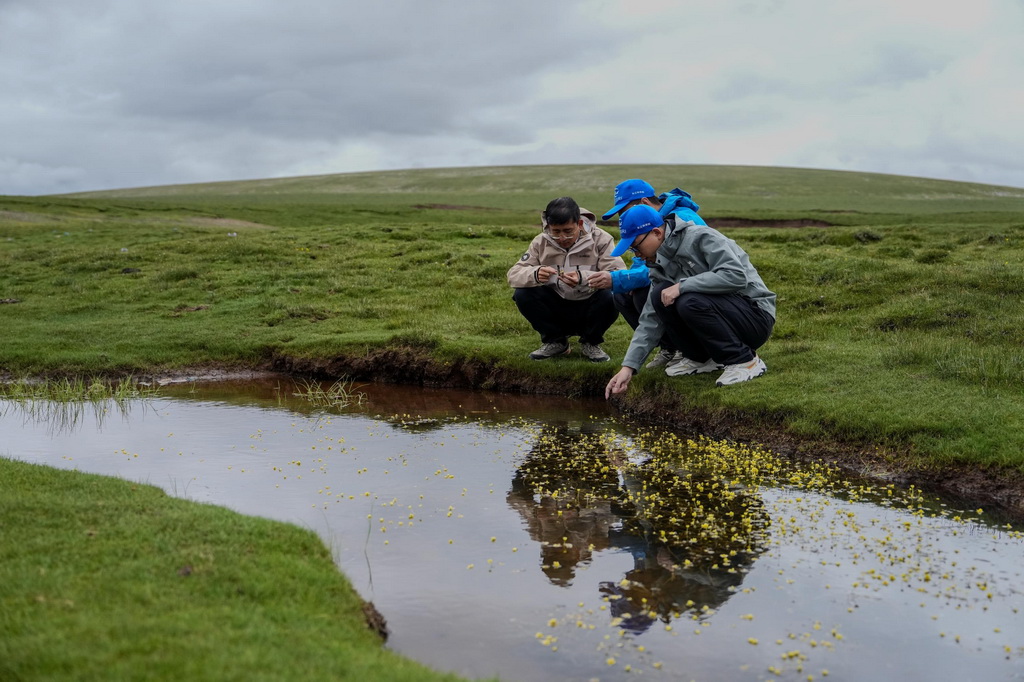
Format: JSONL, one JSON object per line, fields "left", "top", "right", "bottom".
{"left": 601, "top": 178, "right": 708, "bottom": 368}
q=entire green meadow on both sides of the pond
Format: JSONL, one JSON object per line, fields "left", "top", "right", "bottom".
{"left": 0, "top": 161, "right": 1024, "bottom": 680}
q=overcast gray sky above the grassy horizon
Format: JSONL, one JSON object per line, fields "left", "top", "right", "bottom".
{"left": 0, "top": 0, "right": 1024, "bottom": 195}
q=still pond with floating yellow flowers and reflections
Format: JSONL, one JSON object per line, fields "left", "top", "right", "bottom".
{"left": 0, "top": 380, "right": 1024, "bottom": 681}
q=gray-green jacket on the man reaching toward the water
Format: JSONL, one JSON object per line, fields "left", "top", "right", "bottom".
{"left": 623, "top": 215, "right": 775, "bottom": 370}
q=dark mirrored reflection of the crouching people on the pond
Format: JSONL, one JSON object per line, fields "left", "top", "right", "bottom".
{"left": 507, "top": 422, "right": 769, "bottom": 634}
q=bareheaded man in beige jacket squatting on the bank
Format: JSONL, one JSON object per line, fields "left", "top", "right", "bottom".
{"left": 508, "top": 197, "right": 626, "bottom": 363}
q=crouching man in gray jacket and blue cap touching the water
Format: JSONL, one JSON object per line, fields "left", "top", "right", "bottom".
{"left": 604, "top": 205, "right": 775, "bottom": 397}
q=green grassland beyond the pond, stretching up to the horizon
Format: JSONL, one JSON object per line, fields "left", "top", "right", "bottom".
{"left": 0, "top": 166, "right": 1024, "bottom": 469}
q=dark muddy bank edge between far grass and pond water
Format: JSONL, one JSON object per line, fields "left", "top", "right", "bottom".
{"left": 265, "top": 347, "right": 1024, "bottom": 522}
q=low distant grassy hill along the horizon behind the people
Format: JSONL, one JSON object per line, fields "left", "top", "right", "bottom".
{"left": 58, "top": 165, "right": 1024, "bottom": 216}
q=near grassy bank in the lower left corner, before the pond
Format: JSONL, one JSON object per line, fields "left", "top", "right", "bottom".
{"left": 0, "top": 459, "right": 458, "bottom": 682}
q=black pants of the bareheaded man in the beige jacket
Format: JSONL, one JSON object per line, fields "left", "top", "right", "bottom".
{"left": 512, "top": 287, "right": 618, "bottom": 345}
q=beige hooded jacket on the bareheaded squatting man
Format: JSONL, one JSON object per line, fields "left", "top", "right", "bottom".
{"left": 508, "top": 207, "right": 626, "bottom": 301}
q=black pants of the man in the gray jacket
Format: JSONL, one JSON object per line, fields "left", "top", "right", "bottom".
{"left": 652, "top": 285, "right": 775, "bottom": 365}
